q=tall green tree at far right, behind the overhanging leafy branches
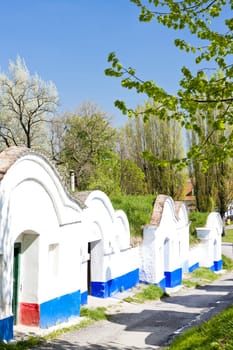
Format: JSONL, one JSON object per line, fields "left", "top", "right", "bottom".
{"left": 187, "top": 89, "right": 233, "bottom": 217}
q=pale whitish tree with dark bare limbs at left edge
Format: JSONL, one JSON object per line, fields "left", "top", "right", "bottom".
{"left": 0, "top": 56, "right": 58, "bottom": 148}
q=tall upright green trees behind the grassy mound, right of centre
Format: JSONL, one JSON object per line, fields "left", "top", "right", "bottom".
{"left": 119, "top": 103, "right": 186, "bottom": 199}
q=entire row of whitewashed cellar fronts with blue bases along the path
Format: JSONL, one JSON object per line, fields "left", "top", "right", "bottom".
{"left": 0, "top": 147, "right": 223, "bottom": 340}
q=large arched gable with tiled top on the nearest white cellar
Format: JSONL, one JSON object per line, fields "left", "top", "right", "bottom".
{"left": 0, "top": 147, "right": 82, "bottom": 252}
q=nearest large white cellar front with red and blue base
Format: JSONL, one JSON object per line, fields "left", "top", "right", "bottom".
{"left": 0, "top": 148, "right": 83, "bottom": 340}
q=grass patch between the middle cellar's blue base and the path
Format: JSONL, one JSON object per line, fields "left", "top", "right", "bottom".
{"left": 124, "top": 284, "right": 167, "bottom": 304}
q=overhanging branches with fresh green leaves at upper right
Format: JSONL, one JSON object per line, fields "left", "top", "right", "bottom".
{"left": 105, "top": 0, "right": 233, "bottom": 165}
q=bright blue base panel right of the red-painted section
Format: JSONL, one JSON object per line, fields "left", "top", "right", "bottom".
{"left": 40, "top": 291, "right": 81, "bottom": 328}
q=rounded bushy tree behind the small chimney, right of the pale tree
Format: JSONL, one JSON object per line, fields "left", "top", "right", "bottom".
{"left": 54, "top": 103, "right": 115, "bottom": 190}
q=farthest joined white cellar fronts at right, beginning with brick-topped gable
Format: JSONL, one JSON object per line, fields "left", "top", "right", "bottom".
{"left": 140, "top": 195, "right": 223, "bottom": 290}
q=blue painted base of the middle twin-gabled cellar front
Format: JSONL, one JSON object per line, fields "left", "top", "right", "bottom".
{"left": 91, "top": 269, "right": 139, "bottom": 298}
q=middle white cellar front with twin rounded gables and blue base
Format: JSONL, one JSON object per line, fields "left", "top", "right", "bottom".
{"left": 82, "top": 191, "right": 139, "bottom": 297}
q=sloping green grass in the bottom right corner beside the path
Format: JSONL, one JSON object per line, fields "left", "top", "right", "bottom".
{"left": 168, "top": 306, "right": 233, "bottom": 350}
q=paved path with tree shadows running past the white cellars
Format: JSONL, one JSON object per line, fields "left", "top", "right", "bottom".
{"left": 26, "top": 272, "right": 233, "bottom": 350}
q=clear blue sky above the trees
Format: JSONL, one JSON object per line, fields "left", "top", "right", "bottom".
{"left": 0, "top": 0, "right": 223, "bottom": 126}
